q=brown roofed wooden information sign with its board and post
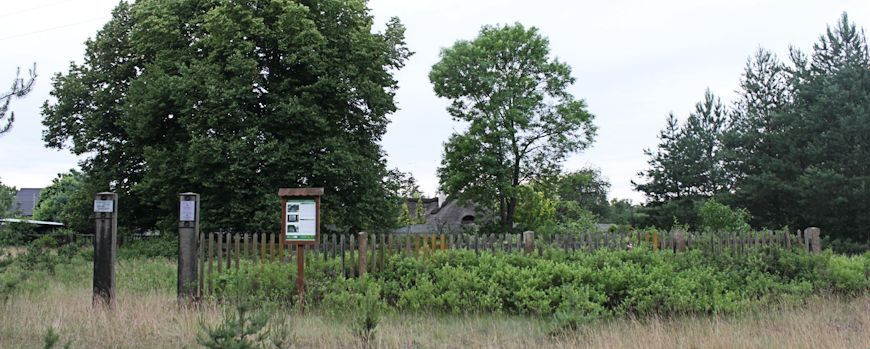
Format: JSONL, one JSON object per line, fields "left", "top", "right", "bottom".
{"left": 278, "top": 188, "right": 323, "bottom": 309}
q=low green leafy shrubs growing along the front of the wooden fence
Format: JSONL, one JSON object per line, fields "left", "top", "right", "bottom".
{"left": 216, "top": 248, "right": 870, "bottom": 318}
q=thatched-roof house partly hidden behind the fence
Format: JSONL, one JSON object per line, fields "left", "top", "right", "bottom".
{"left": 396, "top": 197, "right": 491, "bottom": 234}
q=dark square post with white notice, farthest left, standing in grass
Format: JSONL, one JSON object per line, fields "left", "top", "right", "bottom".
{"left": 92, "top": 192, "right": 118, "bottom": 306}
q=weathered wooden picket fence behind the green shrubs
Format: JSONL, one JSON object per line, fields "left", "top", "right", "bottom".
{"left": 197, "top": 228, "right": 821, "bottom": 295}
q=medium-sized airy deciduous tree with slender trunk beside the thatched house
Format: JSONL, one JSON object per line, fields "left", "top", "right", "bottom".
{"left": 429, "top": 24, "right": 595, "bottom": 229}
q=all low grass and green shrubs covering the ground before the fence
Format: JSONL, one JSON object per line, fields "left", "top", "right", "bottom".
{"left": 0, "top": 243, "right": 870, "bottom": 347}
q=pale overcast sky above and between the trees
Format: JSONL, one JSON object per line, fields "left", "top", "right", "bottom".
{"left": 0, "top": 0, "right": 870, "bottom": 202}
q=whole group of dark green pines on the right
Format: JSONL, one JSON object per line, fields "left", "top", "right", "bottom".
{"left": 635, "top": 13, "right": 870, "bottom": 244}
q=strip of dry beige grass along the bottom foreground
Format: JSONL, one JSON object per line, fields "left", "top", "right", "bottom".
{"left": 0, "top": 284, "right": 870, "bottom": 348}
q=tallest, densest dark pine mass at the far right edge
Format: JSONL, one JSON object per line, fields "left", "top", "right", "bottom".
{"left": 727, "top": 13, "right": 870, "bottom": 240}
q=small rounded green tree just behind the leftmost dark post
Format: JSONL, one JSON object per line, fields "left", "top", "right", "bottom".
{"left": 33, "top": 170, "right": 93, "bottom": 232}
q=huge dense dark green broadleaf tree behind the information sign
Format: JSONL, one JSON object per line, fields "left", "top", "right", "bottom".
{"left": 43, "top": 0, "right": 411, "bottom": 231}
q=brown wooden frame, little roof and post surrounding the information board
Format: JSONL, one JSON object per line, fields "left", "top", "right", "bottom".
{"left": 278, "top": 188, "right": 323, "bottom": 309}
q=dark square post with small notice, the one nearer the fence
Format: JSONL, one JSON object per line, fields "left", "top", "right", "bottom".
{"left": 178, "top": 193, "right": 199, "bottom": 303}
